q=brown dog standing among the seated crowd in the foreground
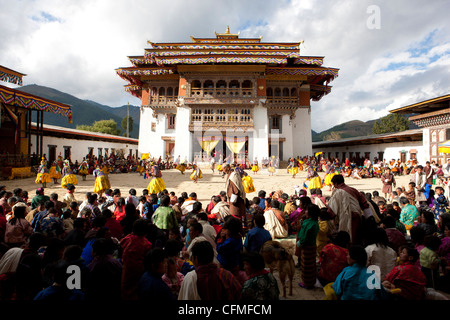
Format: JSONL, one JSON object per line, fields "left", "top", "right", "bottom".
{"left": 261, "top": 240, "right": 295, "bottom": 298}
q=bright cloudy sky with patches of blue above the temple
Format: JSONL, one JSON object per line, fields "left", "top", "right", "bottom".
{"left": 0, "top": 0, "right": 450, "bottom": 132}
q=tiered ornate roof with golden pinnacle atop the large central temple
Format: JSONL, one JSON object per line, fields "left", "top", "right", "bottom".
{"left": 116, "top": 26, "right": 339, "bottom": 100}
